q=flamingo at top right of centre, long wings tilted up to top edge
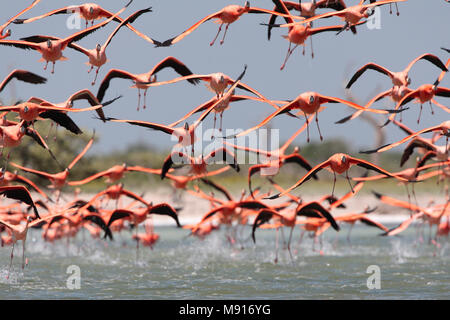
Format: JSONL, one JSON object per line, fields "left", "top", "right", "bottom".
{"left": 281, "top": 0, "right": 406, "bottom": 31}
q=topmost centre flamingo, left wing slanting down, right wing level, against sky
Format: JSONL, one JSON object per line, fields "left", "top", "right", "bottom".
{"left": 156, "top": 1, "right": 302, "bottom": 47}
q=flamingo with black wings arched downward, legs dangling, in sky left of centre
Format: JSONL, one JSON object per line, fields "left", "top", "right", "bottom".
{"left": 97, "top": 57, "right": 198, "bottom": 111}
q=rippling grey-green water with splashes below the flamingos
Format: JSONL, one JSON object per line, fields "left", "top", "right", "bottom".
{"left": 0, "top": 225, "right": 450, "bottom": 299}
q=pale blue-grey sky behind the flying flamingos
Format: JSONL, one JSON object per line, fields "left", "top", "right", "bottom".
{"left": 0, "top": 0, "right": 450, "bottom": 153}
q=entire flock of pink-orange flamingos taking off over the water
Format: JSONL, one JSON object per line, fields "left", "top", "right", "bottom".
{"left": 0, "top": 0, "right": 450, "bottom": 276}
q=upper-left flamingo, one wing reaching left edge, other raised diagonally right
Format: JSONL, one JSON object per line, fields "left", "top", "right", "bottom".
{"left": 0, "top": 2, "right": 131, "bottom": 73}
